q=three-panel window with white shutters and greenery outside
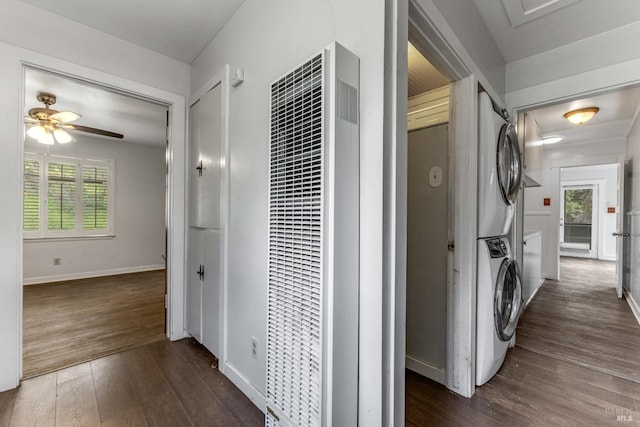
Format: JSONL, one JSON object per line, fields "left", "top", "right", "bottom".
{"left": 23, "top": 153, "right": 113, "bottom": 239}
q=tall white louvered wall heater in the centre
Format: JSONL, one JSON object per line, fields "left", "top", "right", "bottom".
{"left": 266, "top": 43, "right": 360, "bottom": 427}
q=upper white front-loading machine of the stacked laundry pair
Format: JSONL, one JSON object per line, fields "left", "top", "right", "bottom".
{"left": 478, "top": 92, "right": 522, "bottom": 237}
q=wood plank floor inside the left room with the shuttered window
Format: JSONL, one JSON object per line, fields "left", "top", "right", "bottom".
{"left": 23, "top": 270, "right": 165, "bottom": 378}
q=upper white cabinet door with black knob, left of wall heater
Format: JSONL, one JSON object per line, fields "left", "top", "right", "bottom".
{"left": 188, "top": 85, "right": 222, "bottom": 229}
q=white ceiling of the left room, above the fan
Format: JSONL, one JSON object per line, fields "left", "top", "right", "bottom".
{"left": 24, "top": 69, "right": 167, "bottom": 147}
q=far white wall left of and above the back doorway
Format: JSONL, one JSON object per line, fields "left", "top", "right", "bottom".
{"left": 524, "top": 139, "right": 627, "bottom": 278}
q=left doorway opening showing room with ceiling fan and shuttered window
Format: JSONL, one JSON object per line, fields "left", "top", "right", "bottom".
{"left": 20, "top": 67, "right": 172, "bottom": 377}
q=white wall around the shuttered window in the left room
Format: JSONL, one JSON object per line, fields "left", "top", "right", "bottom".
{"left": 23, "top": 135, "right": 166, "bottom": 284}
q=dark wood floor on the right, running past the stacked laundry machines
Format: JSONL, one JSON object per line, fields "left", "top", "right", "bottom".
{"left": 406, "top": 258, "right": 640, "bottom": 426}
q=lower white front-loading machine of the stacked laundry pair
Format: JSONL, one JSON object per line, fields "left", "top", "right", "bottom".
{"left": 476, "top": 237, "right": 523, "bottom": 385}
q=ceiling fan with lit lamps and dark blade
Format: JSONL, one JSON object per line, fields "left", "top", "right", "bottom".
{"left": 24, "top": 92, "right": 124, "bottom": 145}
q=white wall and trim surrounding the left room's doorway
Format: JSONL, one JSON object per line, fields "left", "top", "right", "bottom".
{"left": 0, "top": 4, "right": 189, "bottom": 391}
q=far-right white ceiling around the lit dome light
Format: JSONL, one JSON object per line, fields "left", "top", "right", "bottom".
{"left": 530, "top": 87, "right": 640, "bottom": 148}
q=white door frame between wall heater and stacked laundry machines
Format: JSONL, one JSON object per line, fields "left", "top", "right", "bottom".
{"left": 384, "top": 0, "right": 501, "bottom": 425}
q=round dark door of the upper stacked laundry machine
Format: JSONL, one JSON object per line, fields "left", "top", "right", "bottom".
{"left": 497, "top": 123, "right": 522, "bottom": 205}
